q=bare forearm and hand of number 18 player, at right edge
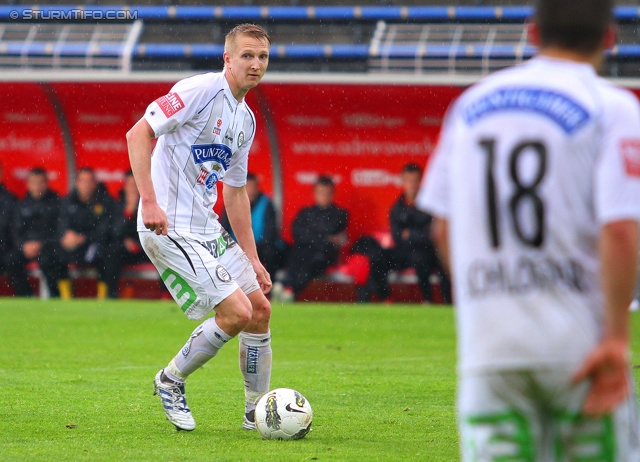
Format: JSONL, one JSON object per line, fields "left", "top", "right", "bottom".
{"left": 574, "top": 221, "right": 638, "bottom": 415}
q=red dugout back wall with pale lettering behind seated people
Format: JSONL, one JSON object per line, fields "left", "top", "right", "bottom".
{"left": 6, "top": 78, "right": 640, "bottom": 249}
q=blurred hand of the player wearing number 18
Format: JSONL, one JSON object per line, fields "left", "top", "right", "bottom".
{"left": 572, "top": 339, "right": 629, "bottom": 417}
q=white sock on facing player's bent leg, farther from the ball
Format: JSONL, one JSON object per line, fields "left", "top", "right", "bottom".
{"left": 164, "top": 318, "right": 232, "bottom": 382}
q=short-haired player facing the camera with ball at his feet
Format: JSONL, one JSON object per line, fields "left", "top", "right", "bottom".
{"left": 127, "top": 24, "right": 271, "bottom": 431}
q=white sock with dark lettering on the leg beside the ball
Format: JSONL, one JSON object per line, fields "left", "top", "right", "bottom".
{"left": 238, "top": 332, "right": 271, "bottom": 413}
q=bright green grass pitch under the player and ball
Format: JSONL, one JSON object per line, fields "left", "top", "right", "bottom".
{"left": 0, "top": 298, "right": 640, "bottom": 462}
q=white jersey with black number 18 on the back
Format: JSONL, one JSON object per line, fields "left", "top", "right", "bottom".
{"left": 418, "top": 57, "right": 640, "bottom": 370}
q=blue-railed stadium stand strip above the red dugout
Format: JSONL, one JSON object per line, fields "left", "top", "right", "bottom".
{"left": 0, "top": 5, "right": 640, "bottom": 77}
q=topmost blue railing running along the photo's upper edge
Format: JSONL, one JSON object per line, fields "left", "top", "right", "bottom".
{"left": 0, "top": 5, "right": 640, "bottom": 21}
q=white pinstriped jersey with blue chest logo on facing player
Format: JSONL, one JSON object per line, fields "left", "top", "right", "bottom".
{"left": 138, "top": 73, "right": 256, "bottom": 234}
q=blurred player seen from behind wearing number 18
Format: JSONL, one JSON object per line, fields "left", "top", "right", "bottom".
{"left": 418, "top": 0, "right": 640, "bottom": 462}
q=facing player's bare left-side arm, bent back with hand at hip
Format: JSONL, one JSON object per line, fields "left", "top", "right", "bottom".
{"left": 127, "top": 118, "right": 168, "bottom": 235}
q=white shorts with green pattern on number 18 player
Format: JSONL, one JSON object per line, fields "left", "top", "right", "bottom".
{"left": 458, "top": 367, "right": 640, "bottom": 462}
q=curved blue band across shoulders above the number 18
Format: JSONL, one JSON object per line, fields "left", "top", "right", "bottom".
{"left": 464, "top": 87, "right": 589, "bottom": 133}
